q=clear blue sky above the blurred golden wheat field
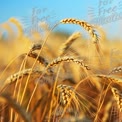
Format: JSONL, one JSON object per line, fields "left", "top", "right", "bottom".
{"left": 0, "top": 0, "right": 122, "bottom": 37}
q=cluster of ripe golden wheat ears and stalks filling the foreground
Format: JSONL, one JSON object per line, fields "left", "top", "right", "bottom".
{"left": 0, "top": 18, "right": 122, "bottom": 122}
